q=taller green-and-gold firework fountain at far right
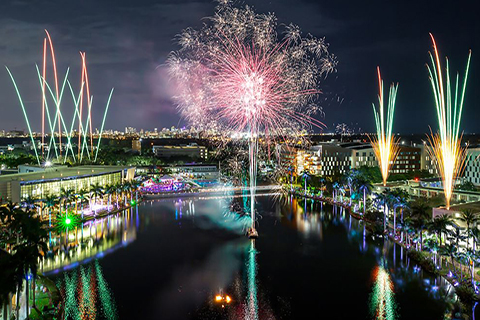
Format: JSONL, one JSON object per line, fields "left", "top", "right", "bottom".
{"left": 427, "top": 34, "right": 472, "bottom": 210}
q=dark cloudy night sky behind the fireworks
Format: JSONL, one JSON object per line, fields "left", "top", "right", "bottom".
{"left": 0, "top": 0, "right": 480, "bottom": 133}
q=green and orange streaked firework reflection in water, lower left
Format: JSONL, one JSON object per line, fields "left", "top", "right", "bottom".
{"left": 57, "top": 260, "right": 118, "bottom": 320}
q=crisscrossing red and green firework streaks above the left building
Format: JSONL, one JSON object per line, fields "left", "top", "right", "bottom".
{"left": 6, "top": 30, "right": 113, "bottom": 165}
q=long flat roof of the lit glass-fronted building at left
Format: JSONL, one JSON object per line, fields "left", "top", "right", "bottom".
{"left": 0, "top": 166, "right": 132, "bottom": 183}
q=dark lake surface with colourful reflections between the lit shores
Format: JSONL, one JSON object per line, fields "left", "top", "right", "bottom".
{"left": 44, "top": 197, "right": 464, "bottom": 319}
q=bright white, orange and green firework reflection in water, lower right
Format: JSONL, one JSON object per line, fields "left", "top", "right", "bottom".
{"left": 370, "top": 264, "right": 396, "bottom": 320}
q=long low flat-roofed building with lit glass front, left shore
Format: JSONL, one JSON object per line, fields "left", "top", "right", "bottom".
{"left": 0, "top": 166, "right": 135, "bottom": 203}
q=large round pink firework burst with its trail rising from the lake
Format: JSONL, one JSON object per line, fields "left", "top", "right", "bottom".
{"left": 168, "top": 2, "right": 336, "bottom": 232}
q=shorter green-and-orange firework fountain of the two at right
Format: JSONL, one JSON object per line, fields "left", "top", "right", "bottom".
{"left": 370, "top": 67, "right": 399, "bottom": 186}
